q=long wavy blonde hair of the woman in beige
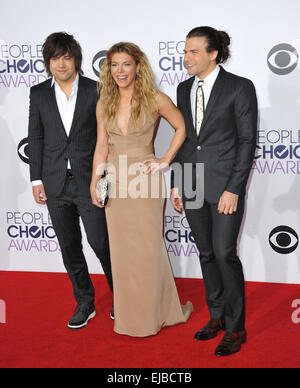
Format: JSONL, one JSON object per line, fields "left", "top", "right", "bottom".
{"left": 99, "top": 42, "right": 158, "bottom": 126}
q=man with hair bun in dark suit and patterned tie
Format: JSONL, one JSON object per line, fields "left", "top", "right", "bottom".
{"left": 171, "top": 27, "right": 258, "bottom": 356}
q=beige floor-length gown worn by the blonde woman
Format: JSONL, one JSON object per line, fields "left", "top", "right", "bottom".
{"left": 105, "top": 114, "right": 193, "bottom": 337}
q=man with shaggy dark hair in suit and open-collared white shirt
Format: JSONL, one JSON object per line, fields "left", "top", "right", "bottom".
{"left": 29, "top": 33, "right": 113, "bottom": 329}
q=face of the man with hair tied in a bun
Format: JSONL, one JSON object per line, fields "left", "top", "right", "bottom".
{"left": 184, "top": 37, "right": 218, "bottom": 79}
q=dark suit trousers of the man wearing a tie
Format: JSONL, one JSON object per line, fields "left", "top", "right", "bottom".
{"left": 185, "top": 198, "right": 245, "bottom": 333}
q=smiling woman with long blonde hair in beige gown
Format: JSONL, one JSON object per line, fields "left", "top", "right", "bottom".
{"left": 91, "top": 43, "right": 193, "bottom": 337}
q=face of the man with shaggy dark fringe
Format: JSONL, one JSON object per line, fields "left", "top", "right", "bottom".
{"left": 50, "top": 53, "right": 76, "bottom": 82}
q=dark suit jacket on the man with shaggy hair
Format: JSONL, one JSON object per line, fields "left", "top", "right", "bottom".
{"left": 28, "top": 76, "right": 98, "bottom": 198}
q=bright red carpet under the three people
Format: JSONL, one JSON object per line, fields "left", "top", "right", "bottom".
{"left": 0, "top": 272, "right": 300, "bottom": 368}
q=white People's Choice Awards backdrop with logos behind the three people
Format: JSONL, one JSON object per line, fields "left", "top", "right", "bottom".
{"left": 0, "top": 0, "right": 300, "bottom": 283}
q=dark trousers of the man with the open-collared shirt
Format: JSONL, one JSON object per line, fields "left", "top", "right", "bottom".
{"left": 47, "top": 177, "right": 113, "bottom": 305}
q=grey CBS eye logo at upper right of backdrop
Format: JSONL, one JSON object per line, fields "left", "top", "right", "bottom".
{"left": 268, "top": 43, "right": 299, "bottom": 75}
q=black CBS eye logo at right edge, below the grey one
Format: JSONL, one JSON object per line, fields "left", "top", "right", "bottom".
{"left": 269, "top": 225, "right": 299, "bottom": 255}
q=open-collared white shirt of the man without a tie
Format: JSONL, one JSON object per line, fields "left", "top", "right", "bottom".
{"left": 32, "top": 74, "right": 79, "bottom": 186}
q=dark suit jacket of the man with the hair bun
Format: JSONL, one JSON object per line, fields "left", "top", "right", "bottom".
{"left": 171, "top": 67, "right": 258, "bottom": 203}
